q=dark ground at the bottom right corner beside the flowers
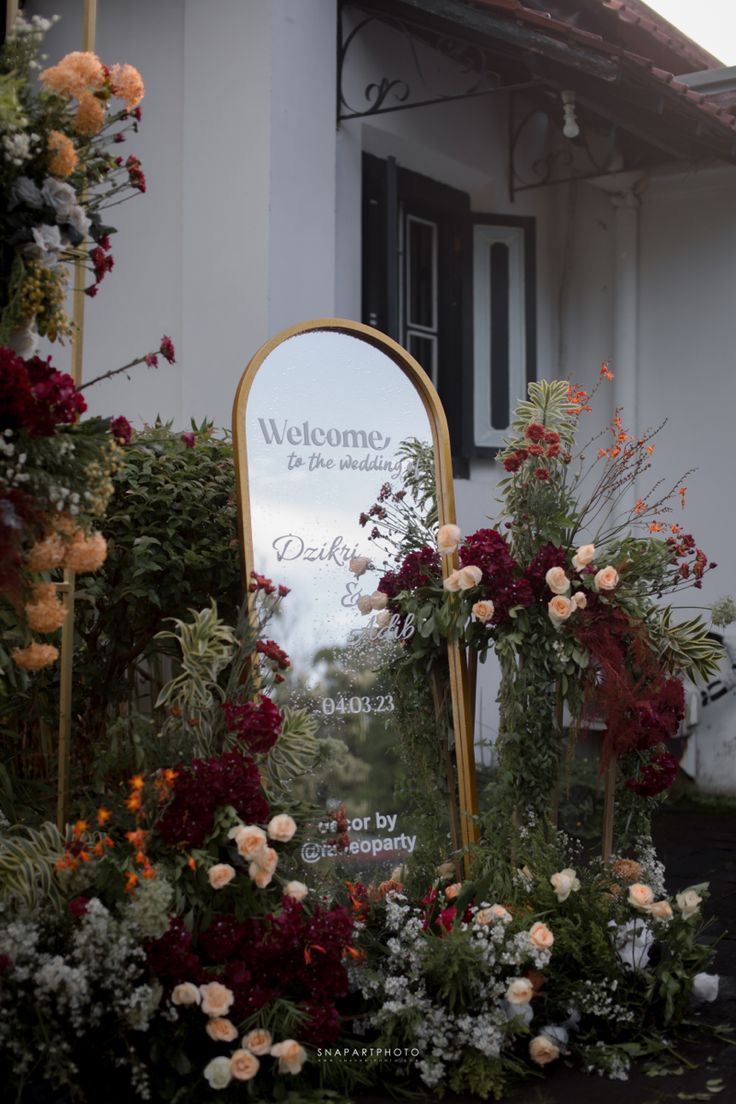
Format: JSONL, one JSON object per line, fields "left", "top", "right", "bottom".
{"left": 361, "top": 802, "right": 736, "bottom": 1104}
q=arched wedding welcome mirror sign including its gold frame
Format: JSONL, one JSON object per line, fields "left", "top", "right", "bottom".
{"left": 234, "top": 319, "right": 473, "bottom": 877}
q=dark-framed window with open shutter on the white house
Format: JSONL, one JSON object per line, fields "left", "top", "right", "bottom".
{"left": 363, "top": 153, "right": 536, "bottom": 478}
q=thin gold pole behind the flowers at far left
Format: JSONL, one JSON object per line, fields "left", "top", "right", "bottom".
{"left": 56, "top": 0, "right": 97, "bottom": 832}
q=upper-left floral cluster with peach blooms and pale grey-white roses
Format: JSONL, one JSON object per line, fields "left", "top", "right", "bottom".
{"left": 0, "top": 15, "right": 146, "bottom": 346}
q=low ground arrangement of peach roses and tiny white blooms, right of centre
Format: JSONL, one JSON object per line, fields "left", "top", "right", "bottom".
{"left": 351, "top": 835, "right": 718, "bottom": 1100}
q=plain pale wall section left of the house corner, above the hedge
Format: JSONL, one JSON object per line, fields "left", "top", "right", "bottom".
{"left": 28, "top": 0, "right": 335, "bottom": 426}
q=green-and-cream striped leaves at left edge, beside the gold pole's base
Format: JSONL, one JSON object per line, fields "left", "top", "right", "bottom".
{"left": 0, "top": 821, "right": 64, "bottom": 912}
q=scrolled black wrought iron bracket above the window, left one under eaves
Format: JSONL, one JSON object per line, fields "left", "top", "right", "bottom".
{"left": 337, "top": 0, "right": 543, "bottom": 125}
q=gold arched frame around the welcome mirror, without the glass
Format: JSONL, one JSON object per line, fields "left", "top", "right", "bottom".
{"left": 233, "top": 318, "right": 478, "bottom": 856}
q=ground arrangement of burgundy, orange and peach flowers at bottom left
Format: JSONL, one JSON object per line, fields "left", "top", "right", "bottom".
{"left": 0, "top": 591, "right": 359, "bottom": 1102}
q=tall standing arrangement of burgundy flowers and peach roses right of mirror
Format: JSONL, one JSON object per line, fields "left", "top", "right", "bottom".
{"left": 350, "top": 379, "right": 719, "bottom": 866}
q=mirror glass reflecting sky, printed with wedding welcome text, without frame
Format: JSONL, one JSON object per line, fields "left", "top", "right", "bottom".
{"left": 245, "top": 330, "right": 433, "bottom": 877}
